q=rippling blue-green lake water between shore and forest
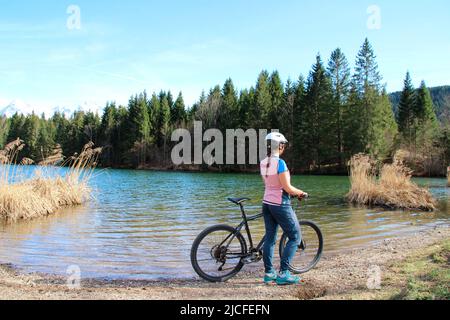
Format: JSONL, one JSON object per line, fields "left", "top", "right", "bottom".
{"left": 0, "top": 167, "right": 450, "bottom": 279}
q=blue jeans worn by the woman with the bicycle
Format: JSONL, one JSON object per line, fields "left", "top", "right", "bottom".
{"left": 263, "top": 204, "right": 302, "bottom": 273}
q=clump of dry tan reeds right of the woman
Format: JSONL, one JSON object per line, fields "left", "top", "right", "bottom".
{"left": 347, "top": 154, "right": 436, "bottom": 211}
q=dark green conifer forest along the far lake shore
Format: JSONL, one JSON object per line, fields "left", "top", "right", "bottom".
{"left": 0, "top": 39, "right": 450, "bottom": 175}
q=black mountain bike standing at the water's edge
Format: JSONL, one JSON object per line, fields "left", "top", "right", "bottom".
{"left": 191, "top": 198, "right": 324, "bottom": 282}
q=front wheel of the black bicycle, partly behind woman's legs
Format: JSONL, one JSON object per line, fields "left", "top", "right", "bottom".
{"left": 280, "top": 221, "right": 323, "bottom": 274}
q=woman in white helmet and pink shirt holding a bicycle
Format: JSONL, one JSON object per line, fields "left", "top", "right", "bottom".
{"left": 261, "top": 133, "right": 308, "bottom": 285}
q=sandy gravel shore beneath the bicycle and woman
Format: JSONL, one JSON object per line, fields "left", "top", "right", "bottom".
{"left": 0, "top": 226, "right": 450, "bottom": 300}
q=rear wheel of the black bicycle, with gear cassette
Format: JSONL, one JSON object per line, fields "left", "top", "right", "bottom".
{"left": 191, "top": 225, "right": 247, "bottom": 282}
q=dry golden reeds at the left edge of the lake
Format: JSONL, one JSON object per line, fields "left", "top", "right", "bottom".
{"left": 0, "top": 139, "right": 102, "bottom": 221}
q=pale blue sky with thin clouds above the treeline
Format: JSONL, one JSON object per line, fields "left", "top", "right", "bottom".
{"left": 0, "top": 0, "right": 450, "bottom": 114}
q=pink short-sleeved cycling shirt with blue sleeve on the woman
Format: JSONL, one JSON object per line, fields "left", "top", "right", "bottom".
{"left": 261, "top": 156, "right": 291, "bottom": 206}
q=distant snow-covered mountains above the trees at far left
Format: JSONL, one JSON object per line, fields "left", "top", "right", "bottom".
{"left": 0, "top": 100, "right": 103, "bottom": 117}
